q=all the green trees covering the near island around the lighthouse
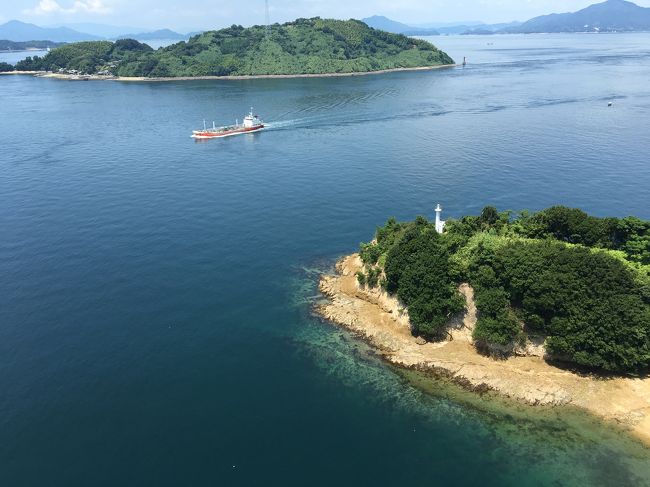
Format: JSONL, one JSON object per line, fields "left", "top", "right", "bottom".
{"left": 360, "top": 207, "right": 650, "bottom": 372}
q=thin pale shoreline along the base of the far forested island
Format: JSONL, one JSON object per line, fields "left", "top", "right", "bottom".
{"left": 0, "top": 64, "right": 458, "bottom": 83}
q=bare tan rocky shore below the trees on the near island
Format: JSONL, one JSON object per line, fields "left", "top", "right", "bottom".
{"left": 316, "top": 254, "right": 650, "bottom": 447}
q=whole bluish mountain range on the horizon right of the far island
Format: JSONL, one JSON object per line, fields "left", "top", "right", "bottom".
{"left": 363, "top": 0, "right": 650, "bottom": 36}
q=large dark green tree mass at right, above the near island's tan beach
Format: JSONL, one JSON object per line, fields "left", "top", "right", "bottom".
{"left": 488, "top": 242, "right": 650, "bottom": 372}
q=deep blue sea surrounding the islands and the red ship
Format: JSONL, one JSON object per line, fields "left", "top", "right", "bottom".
{"left": 0, "top": 34, "right": 650, "bottom": 487}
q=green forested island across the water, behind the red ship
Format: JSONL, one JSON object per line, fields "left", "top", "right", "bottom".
{"left": 16, "top": 18, "right": 454, "bottom": 78}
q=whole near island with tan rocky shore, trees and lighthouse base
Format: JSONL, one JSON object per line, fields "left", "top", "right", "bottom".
{"left": 317, "top": 207, "right": 650, "bottom": 444}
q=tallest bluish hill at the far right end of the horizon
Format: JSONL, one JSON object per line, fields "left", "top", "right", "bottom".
{"left": 504, "top": 0, "right": 650, "bottom": 34}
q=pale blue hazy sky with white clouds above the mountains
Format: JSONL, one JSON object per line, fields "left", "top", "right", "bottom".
{"left": 0, "top": 0, "right": 650, "bottom": 31}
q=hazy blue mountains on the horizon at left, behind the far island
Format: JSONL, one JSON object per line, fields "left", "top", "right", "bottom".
{"left": 0, "top": 20, "right": 190, "bottom": 42}
